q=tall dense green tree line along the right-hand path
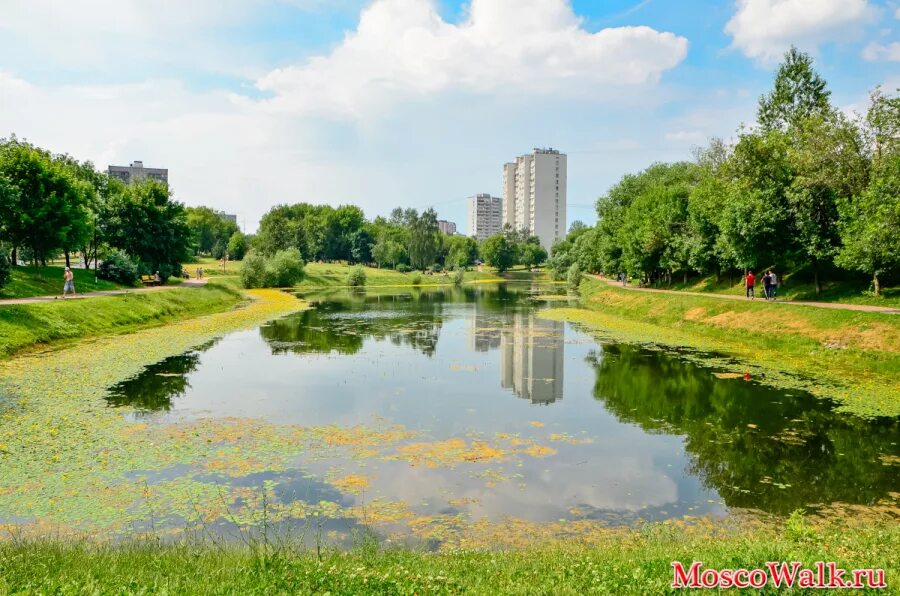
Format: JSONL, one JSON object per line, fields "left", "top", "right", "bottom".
{"left": 549, "top": 48, "right": 900, "bottom": 294}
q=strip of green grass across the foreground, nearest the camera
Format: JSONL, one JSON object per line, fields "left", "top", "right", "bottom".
{"left": 0, "top": 517, "right": 900, "bottom": 594}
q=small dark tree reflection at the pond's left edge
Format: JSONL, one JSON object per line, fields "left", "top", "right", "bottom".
{"left": 106, "top": 342, "right": 215, "bottom": 412}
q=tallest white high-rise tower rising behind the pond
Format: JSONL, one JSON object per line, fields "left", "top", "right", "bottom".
{"left": 503, "top": 149, "right": 567, "bottom": 250}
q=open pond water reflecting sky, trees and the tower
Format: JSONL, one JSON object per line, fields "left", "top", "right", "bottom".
{"left": 107, "top": 283, "right": 900, "bottom": 536}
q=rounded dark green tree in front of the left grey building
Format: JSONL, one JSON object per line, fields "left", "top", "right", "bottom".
{"left": 104, "top": 180, "right": 191, "bottom": 279}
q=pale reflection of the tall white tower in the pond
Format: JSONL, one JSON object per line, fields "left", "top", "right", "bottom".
{"left": 500, "top": 313, "right": 565, "bottom": 404}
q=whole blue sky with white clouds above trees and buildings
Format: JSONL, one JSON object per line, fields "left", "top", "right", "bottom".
{"left": 0, "top": 0, "right": 900, "bottom": 232}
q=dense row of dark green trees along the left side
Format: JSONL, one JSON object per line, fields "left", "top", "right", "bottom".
{"left": 0, "top": 136, "right": 253, "bottom": 286}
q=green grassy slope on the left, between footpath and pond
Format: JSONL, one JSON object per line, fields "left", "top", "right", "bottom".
{"left": 0, "top": 284, "right": 243, "bottom": 357}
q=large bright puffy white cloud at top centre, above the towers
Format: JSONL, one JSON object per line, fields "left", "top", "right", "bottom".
{"left": 257, "top": 0, "right": 687, "bottom": 116}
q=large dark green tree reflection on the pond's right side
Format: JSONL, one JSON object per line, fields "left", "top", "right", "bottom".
{"left": 591, "top": 346, "right": 900, "bottom": 513}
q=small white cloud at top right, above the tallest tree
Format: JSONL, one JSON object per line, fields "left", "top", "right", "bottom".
{"left": 725, "top": 0, "right": 877, "bottom": 61}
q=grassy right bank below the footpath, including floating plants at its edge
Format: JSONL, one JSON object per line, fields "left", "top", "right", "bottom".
{"left": 542, "top": 279, "right": 900, "bottom": 416}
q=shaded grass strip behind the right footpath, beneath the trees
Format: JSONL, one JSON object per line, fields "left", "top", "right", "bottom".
{"left": 659, "top": 269, "right": 900, "bottom": 307}
